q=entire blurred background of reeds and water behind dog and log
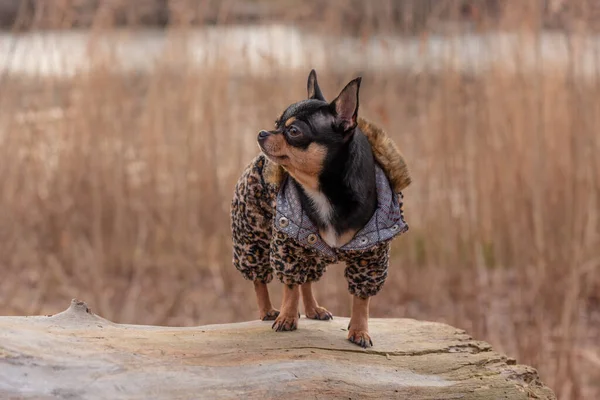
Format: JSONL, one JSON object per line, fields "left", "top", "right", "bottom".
{"left": 0, "top": 0, "right": 600, "bottom": 399}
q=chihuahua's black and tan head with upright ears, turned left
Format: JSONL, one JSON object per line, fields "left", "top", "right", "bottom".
{"left": 258, "top": 70, "right": 361, "bottom": 190}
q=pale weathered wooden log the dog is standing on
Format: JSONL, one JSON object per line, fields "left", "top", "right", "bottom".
{"left": 0, "top": 300, "right": 556, "bottom": 400}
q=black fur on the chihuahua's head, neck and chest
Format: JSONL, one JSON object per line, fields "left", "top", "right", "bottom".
{"left": 273, "top": 70, "right": 377, "bottom": 238}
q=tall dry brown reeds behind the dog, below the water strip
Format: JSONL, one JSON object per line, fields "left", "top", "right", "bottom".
{"left": 0, "top": 1, "right": 600, "bottom": 399}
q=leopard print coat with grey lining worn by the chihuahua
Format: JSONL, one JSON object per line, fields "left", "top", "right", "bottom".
{"left": 231, "top": 119, "right": 410, "bottom": 298}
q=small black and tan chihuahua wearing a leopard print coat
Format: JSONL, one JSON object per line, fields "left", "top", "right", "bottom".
{"left": 231, "top": 70, "right": 410, "bottom": 347}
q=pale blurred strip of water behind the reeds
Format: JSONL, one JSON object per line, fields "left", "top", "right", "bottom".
{"left": 0, "top": 25, "right": 600, "bottom": 78}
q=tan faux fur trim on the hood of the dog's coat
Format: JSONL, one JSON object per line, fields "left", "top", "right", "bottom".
{"left": 264, "top": 118, "right": 411, "bottom": 193}
